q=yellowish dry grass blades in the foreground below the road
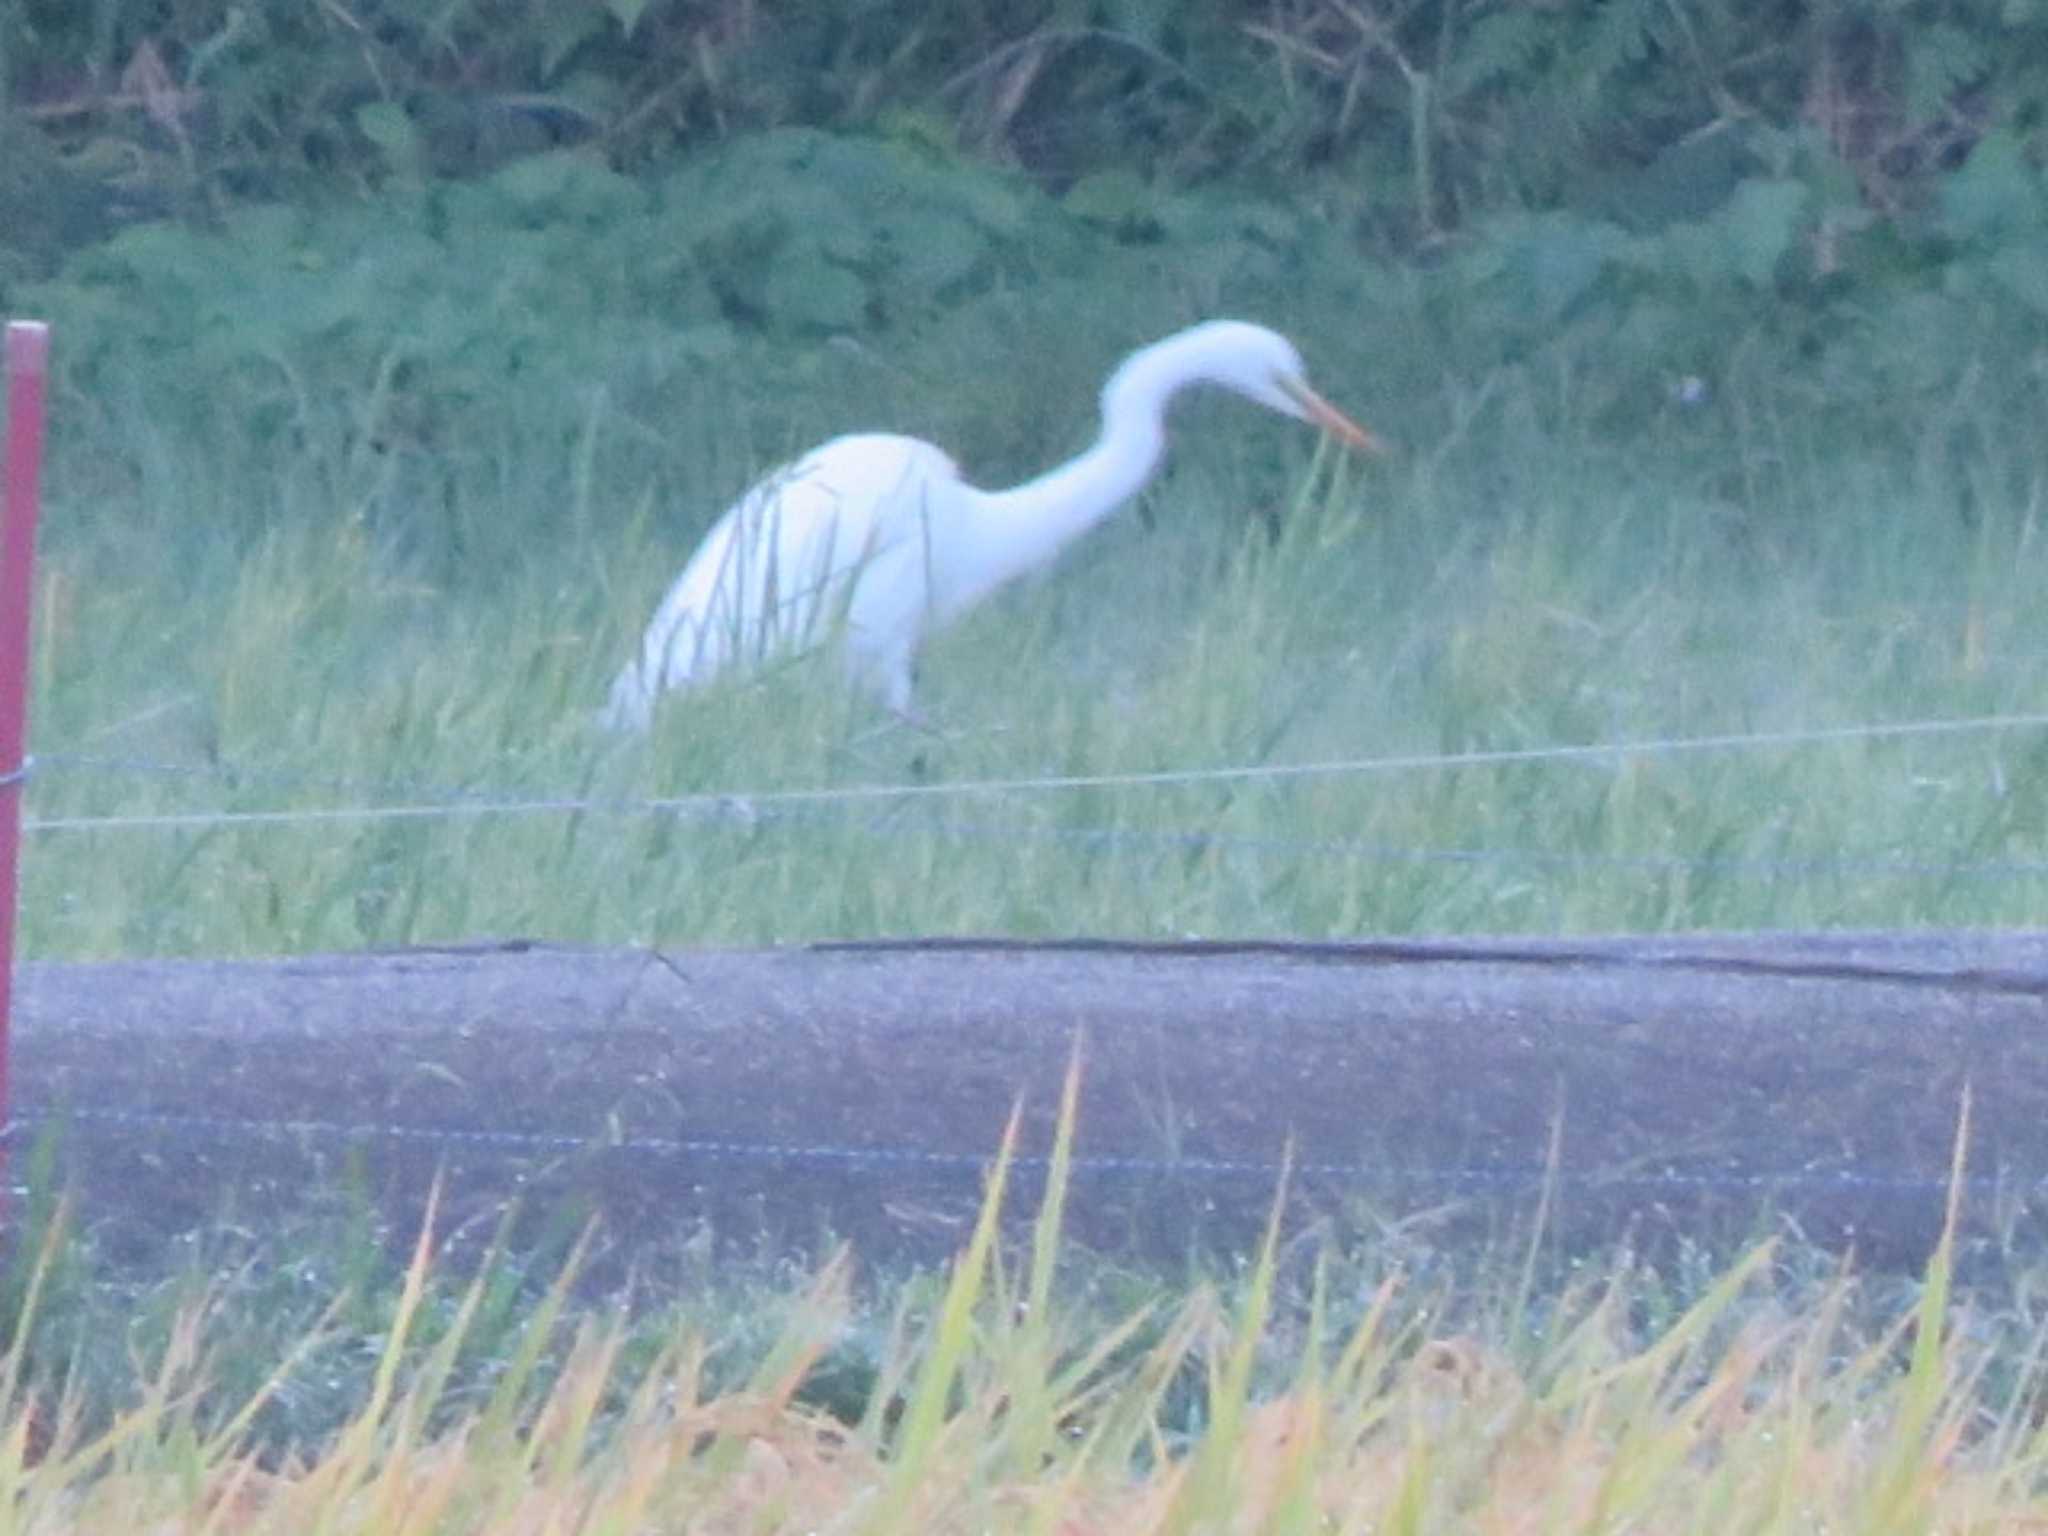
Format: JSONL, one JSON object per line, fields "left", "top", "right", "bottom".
{"left": 0, "top": 1081, "right": 2048, "bottom": 1536}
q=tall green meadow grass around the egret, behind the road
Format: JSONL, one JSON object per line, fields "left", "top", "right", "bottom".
{"left": 23, "top": 311, "right": 2048, "bottom": 956}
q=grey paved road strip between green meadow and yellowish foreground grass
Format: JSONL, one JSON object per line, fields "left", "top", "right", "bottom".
{"left": 14, "top": 932, "right": 2048, "bottom": 1264}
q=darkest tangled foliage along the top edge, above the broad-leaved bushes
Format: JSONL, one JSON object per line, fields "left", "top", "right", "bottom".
{"left": 12, "top": 0, "right": 2048, "bottom": 242}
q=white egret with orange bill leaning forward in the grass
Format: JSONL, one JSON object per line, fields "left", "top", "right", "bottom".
{"left": 604, "top": 319, "right": 1378, "bottom": 731}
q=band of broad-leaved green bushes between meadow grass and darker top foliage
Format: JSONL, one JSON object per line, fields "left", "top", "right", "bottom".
{"left": 23, "top": 115, "right": 2048, "bottom": 536}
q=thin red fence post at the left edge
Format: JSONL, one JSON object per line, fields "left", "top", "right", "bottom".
{"left": 0, "top": 319, "right": 49, "bottom": 1223}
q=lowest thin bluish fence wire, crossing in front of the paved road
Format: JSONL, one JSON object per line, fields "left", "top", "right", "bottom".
{"left": 0, "top": 1106, "right": 2048, "bottom": 1196}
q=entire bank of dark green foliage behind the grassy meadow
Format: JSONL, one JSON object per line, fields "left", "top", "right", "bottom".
{"left": 0, "top": 0, "right": 2048, "bottom": 548}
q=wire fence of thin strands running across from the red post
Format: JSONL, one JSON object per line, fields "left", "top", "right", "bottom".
{"left": 12, "top": 713, "right": 2048, "bottom": 1253}
